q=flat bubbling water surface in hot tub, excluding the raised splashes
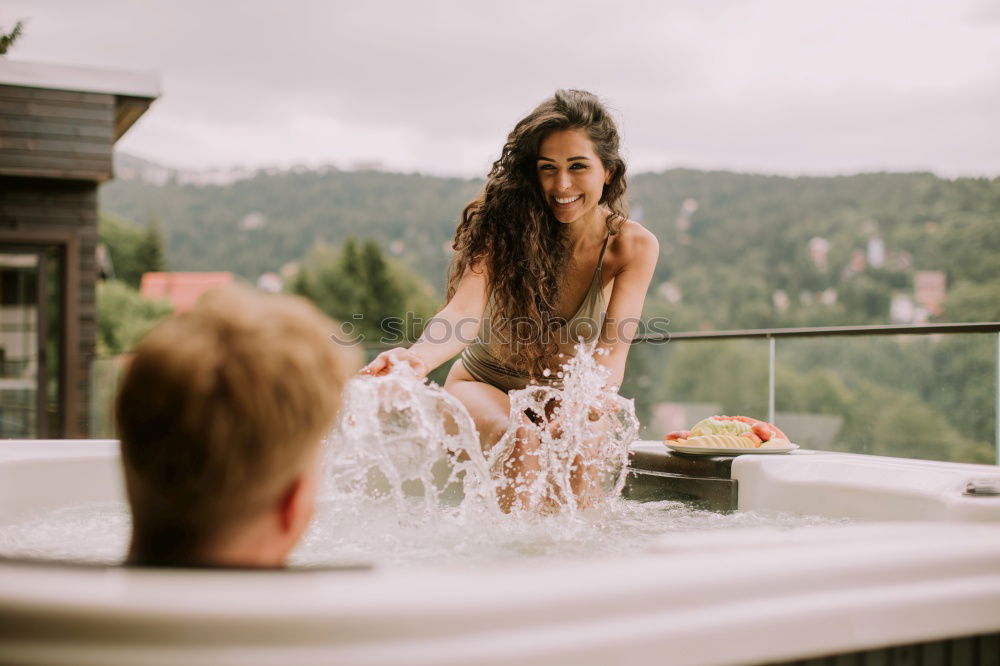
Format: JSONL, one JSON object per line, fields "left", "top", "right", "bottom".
{"left": 0, "top": 499, "right": 844, "bottom": 569}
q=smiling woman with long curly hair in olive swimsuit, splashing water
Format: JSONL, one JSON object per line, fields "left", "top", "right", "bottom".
{"left": 363, "top": 90, "right": 659, "bottom": 510}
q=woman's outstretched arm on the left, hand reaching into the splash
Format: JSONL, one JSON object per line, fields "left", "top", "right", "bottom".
{"left": 361, "top": 260, "right": 486, "bottom": 375}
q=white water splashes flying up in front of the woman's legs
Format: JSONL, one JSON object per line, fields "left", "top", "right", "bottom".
{"left": 327, "top": 343, "right": 639, "bottom": 520}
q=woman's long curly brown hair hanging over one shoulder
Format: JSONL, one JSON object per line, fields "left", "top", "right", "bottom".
{"left": 448, "top": 90, "right": 628, "bottom": 377}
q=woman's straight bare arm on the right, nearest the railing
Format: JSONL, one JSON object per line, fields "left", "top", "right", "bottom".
{"left": 597, "top": 223, "right": 660, "bottom": 386}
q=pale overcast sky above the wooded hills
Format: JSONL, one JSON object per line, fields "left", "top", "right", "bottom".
{"left": 0, "top": 0, "right": 1000, "bottom": 176}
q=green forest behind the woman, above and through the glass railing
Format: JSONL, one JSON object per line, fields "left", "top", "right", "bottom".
{"left": 100, "top": 170, "right": 1000, "bottom": 462}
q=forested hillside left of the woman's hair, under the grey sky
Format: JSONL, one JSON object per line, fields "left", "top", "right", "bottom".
{"left": 100, "top": 163, "right": 480, "bottom": 290}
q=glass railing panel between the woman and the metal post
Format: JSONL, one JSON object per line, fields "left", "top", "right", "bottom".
{"left": 621, "top": 338, "right": 768, "bottom": 440}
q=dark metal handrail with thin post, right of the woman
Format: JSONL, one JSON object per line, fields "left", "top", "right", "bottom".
{"left": 632, "top": 322, "right": 1000, "bottom": 464}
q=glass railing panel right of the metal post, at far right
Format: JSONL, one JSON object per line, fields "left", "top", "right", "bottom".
{"left": 775, "top": 333, "right": 997, "bottom": 463}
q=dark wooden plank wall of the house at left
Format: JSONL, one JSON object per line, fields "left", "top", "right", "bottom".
{"left": 0, "top": 79, "right": 113, "bottom": 437}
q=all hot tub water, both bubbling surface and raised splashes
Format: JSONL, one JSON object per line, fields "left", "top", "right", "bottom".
{"left": 0, "top": 347, "right": 852, "bottom": 568}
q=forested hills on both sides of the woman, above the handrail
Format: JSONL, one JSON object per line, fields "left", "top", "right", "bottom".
{"left": 100, "top": 165, "right": 1000, "bottom": 330}
